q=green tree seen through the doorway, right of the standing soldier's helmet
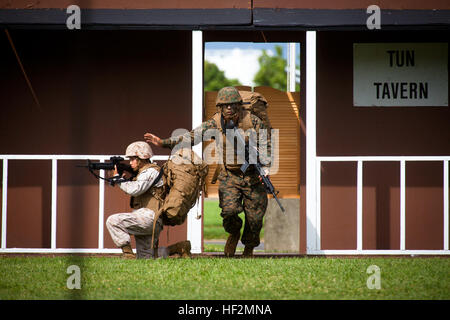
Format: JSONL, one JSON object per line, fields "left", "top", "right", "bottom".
{"left": 253, "top": 46, "right": 300, "bottom": 91}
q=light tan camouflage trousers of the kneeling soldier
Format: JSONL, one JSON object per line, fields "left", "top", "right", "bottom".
{"left": 106, "top": 208, "right": 162, "bottom": 259}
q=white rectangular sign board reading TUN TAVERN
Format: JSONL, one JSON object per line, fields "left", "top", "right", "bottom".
{"left": 353, "top": 43, "right": 448, "bottom": 107}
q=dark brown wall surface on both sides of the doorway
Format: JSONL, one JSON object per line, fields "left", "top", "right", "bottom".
{"left": 0, "top": 27, "right": 450, "bottom": 253}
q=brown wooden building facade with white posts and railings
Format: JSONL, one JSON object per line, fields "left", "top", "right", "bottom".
{"left": 0, "top": 0, "right": 450, "bottom": 254}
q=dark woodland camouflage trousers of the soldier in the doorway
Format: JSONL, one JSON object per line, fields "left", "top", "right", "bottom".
{"left": 219, "top": 170, "right": 267, "bottom": 247}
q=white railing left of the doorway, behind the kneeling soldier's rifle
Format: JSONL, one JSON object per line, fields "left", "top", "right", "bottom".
{"left": 0, "top": 154, "right": 168, "bottom": 253}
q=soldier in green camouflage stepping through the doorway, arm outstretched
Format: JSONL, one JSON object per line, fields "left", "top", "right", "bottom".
{"left": 144, "top": 87, "right": 270, "bottom": 256}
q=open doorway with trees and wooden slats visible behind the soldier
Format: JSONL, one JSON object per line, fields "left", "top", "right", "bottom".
{"left": 203, "top": 42, "right": 300, "bottom": 255}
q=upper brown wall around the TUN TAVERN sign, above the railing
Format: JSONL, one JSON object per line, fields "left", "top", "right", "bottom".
{"left": 317, "top": 31, "right": 450, "bottom": 156}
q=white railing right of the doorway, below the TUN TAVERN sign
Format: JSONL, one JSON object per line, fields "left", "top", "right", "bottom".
{"left": 308, "top": 156, "right": 450, "bottom": 255}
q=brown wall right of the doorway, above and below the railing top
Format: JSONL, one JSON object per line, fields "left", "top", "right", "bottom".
{"left": 317, "top": 31, "right": 450, "bottom": 249}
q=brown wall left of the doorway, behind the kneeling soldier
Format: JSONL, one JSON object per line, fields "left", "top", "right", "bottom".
{"left": 0, "top": 30, "right": 191, "bottom": 248}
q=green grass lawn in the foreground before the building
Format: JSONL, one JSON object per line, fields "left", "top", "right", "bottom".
{"left": 0, "top": 257, "right": 450, "bottom": 300}
